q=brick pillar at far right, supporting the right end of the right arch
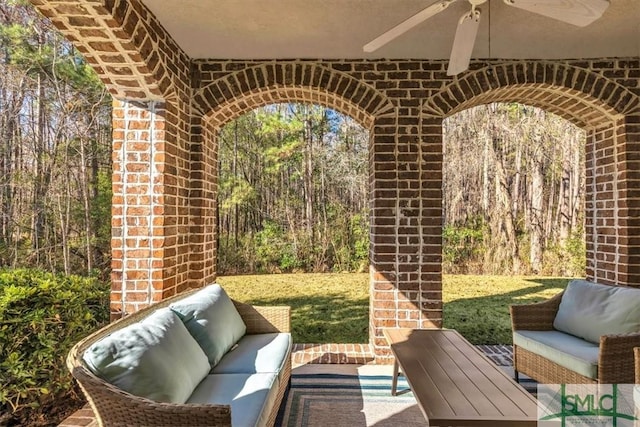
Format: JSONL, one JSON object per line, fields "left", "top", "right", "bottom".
{"left": 585, "top": 116, "right": 640, "bottom": 286}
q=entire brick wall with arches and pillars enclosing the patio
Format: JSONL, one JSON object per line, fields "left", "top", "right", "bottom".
{"left": 31, "top": 0, "right": 640, "bottom": 360}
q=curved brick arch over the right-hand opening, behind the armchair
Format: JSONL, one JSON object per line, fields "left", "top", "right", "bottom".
{"left": 423, "top": 61, "right": 640, "bottom": 129}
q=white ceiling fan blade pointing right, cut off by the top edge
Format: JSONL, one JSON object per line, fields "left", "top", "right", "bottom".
{"left": 504, "top": 0, "right": 609, "bottom": 27}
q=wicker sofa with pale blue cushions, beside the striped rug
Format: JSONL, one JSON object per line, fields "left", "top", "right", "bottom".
{"left": 67, "top": 284, "right": 292, "bottom": 427}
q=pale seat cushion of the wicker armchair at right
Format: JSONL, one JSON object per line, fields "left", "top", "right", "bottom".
{"left": 513, "top": 331, "right": 600, "bottom": 379}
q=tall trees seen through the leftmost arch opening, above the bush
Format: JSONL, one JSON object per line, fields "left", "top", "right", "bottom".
{"left": 0, "top": 1, "right": 111, "bottom": 276}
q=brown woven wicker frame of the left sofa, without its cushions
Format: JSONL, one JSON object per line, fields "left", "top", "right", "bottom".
{"left": 67, "top": 289, "right": 291, "bottom": 426}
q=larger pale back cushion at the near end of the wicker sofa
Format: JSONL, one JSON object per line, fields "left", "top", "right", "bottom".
{"left": 83, "top": 308, "right": 210, "bottom": 403}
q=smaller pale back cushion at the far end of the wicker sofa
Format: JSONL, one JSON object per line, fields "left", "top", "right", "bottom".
{"left": 169, "top": 284, "right": 247, "bottom": 367}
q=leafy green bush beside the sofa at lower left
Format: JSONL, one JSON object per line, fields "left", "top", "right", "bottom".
{"left": 0, "top": 270, "right": 109, "bottom": 425}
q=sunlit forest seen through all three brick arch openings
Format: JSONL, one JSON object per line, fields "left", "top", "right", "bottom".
{"left": 0, "top": 0, "right": 585, "bottom": 281}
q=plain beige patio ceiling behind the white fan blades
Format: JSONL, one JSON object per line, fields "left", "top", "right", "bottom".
{"left": 142, "top": 0, "right": 640, "bottom": 59}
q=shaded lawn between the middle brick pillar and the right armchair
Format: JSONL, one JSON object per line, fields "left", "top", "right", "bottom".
{"left": 443, "top": 278, "right": 571, "bottom": 344}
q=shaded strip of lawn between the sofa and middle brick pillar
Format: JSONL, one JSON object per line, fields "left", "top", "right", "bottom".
{"left": 244, "top": 295, "right": 369, "bottom": 344}
